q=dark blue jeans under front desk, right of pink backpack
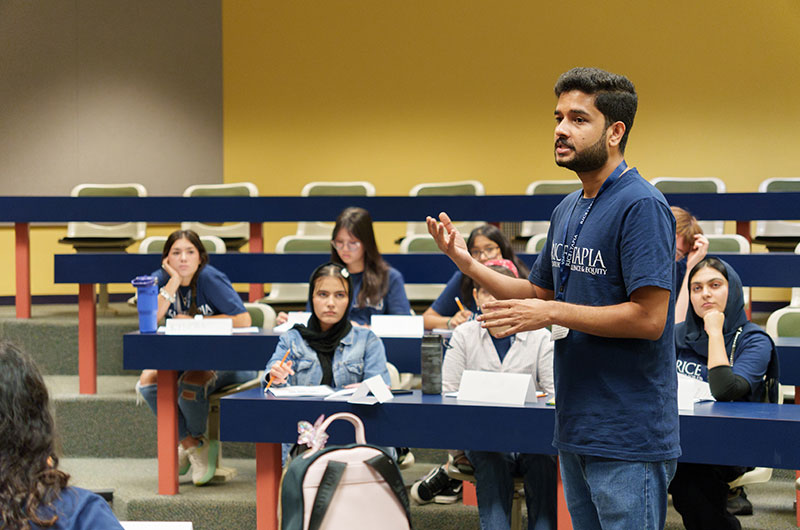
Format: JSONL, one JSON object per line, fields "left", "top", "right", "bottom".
{"left": 464, "top": 451, "right": 560, "bottom": 530}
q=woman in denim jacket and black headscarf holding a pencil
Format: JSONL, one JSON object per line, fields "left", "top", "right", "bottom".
{"left": 265, "top": 263, "right": 389, "bottom": 388}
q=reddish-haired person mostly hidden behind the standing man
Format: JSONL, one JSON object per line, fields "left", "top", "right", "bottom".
{"left": 670, "top": 206, "right": 708, "bottom": 324}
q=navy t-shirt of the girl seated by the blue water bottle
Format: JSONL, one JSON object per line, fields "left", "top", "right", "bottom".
{"left": 153, "top": 265, "right": 247, "bottom": 318}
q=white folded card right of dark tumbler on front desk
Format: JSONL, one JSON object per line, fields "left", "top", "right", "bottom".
{"left": 458, "top": 370, "right": 538, "bottom": 406}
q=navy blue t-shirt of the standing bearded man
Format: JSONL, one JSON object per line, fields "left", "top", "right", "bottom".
{"left": 529, "top": 169, "right": 680, "bottom": 461}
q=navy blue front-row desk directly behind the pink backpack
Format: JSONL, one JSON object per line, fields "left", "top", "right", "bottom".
{"left": 221, "top": 388, "right": 800, "bottom": 469}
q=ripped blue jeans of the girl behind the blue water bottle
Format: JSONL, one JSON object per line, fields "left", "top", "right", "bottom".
{"left": 136, "top": 370, "right": 258, "bottom": 440}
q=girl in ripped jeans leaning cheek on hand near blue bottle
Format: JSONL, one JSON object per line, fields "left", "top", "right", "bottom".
{"left": 136, "top": 230, "right": 256, "bottom": 486}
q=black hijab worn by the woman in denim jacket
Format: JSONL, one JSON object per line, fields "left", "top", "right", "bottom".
{"left": 292, "top": 262, "right": 353, "bottom": 361}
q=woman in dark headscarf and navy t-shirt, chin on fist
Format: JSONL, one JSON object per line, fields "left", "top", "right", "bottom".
{"left": 669, "top": 257, "right": 777, "bottom": 530}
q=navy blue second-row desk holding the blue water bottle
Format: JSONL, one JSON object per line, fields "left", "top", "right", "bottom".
{"left": 122, "top": 330, "right": 422, "bottom": 374}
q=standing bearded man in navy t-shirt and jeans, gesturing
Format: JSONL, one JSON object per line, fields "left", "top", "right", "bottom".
{"left": 428, "top": 68, "right": 680, "bottom": 530}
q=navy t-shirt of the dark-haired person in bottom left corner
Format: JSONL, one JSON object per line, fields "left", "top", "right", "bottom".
{"left": 31, "top": 487, "right": 122, "bottom": 530}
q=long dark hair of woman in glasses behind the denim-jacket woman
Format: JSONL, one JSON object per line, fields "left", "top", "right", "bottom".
{"left": 331, "top": 206, "right": 389, "bottom": 307}
